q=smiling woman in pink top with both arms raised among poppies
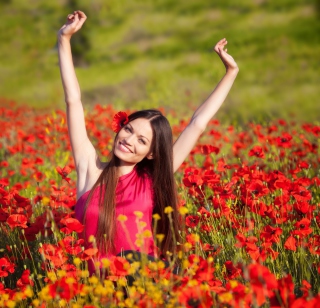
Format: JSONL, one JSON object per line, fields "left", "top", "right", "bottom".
{"left": 58, "top": 11, "right": 239, "bottom": 272}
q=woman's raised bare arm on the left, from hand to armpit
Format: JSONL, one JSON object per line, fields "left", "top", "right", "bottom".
{"left": 58, "top": 11, "right": 95, "bottom": 173}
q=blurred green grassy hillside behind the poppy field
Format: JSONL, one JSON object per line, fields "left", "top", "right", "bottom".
{"left": 0, "top": 0, "right": 320, "bottom": 121}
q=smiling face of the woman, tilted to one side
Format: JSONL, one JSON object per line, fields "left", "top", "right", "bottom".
{"left": 114, "top": 118, "right": 153, "bottom": 165}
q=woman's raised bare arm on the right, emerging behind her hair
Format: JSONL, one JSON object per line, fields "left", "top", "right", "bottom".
{"left": 173, "top": 39, "right": 239, "bottom": 171}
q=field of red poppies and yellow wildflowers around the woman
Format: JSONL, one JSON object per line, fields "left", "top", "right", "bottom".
{"left": 0, "top": 100, "right": 320, "bottom": 308}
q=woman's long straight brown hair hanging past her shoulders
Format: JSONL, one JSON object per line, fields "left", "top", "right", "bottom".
{"left": 84, "top": 109, "right": 179, "bottom": 257}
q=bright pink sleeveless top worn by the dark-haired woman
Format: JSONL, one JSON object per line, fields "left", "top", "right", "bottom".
{"left": 75, "top": 168, "right": 155, "bottom": 270}
